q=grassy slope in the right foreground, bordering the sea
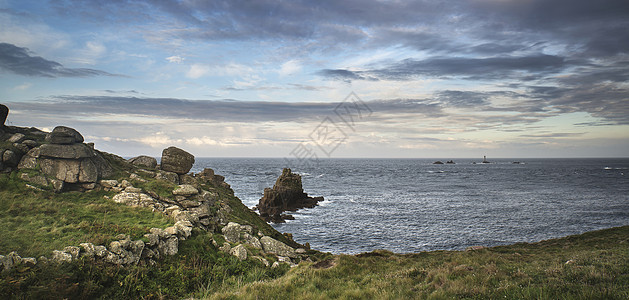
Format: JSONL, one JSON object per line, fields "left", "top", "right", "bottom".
{"left": 210, "top": 226, "right": 629, "bottom": 299}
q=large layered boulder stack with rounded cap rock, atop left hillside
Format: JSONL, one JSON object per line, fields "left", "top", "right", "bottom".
{"left": 18, "top": 126, "right": 113, "bottom": 191}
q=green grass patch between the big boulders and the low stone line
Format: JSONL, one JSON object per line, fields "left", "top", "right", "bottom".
{"left": 0, "top": 173, "right": 172, "bottom": 257}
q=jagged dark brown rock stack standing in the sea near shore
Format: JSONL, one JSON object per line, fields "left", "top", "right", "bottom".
{"left": 257, "top": 168, "right": 323, "bottom": 223}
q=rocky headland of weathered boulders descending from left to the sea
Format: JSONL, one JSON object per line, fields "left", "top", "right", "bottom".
{"left": 0, "top": 105, "right": 310, "bottom": 271}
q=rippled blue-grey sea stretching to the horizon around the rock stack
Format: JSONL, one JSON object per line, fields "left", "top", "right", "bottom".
{"left": 192, "top": 158, "right": 629, "bottom": 254}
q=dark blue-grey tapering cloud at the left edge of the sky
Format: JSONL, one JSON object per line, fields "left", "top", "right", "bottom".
{"left": 0, "top": 43, "right": 121, "bottom": 78}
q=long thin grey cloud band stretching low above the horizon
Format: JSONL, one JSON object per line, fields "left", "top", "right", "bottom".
{"left": 10, "top": 96, "right": 441, "bottom": 122}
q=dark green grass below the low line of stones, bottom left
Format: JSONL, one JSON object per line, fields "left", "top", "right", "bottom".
{"left": 0, "top": 230, "right": 288, "bottom": 299}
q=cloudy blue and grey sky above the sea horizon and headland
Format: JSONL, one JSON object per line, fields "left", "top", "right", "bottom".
{"left": 0, "top": 0, "right": 629, "bottom": 161}
